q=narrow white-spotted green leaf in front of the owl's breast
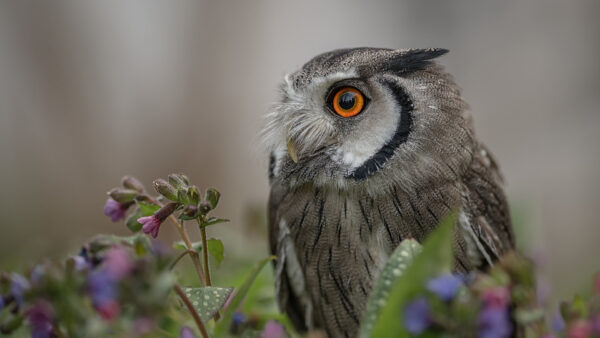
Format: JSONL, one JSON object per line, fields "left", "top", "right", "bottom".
{"left": 360, "top": 239, "right": 423, "bottom": 337}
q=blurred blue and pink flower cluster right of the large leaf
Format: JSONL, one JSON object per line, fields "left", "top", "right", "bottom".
{"left": 403, "top": 254, "right": 600, "bottom": 338}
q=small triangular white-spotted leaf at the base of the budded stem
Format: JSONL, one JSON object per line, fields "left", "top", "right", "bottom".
{"left": 182, "top": 286, "right": 233, "bottom": 323}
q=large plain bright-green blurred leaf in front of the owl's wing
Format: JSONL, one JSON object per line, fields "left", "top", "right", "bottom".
{"left": 371, "top": 213, "right": 457, "bottom": 337}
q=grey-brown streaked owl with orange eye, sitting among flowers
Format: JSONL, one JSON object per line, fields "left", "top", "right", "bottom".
{"left": 262, "top": 48, "right": 514, "bottom": 337}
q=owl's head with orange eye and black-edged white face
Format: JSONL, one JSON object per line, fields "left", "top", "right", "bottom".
{"left": 262, "top": 48, "right": 473, "bottom": 189}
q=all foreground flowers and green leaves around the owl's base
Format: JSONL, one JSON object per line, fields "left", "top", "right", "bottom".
{"left": 0, "top": 174, "right": 600, "bottom": 338}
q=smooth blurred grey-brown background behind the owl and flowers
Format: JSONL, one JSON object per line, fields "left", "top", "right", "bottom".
{"left": 0, "top": 0, "right": 600, "bottom": 297}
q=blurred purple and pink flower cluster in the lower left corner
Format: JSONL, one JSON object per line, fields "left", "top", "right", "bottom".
{"left": 0, "top": 236, "right": 175, "bottom": 338}
